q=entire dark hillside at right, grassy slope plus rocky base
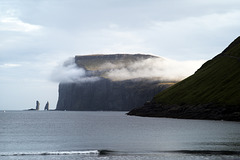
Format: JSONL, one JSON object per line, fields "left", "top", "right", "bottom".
{"left": 128, "top": 37, "right": 240, "bottom": 121}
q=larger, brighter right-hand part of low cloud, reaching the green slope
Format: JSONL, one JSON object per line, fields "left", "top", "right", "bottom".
{"left": 104, "top": 58, "right": 205, "bottom": 81}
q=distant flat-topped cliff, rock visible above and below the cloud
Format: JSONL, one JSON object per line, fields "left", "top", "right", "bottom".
{"left": 56, "top": 54, "right": 174, "bottom": 111}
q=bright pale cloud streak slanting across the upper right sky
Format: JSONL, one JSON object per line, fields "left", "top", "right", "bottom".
{"left": 152, "top": 11, "right": 240, "bottom": 32}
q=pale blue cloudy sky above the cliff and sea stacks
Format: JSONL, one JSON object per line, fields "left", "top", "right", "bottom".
{"left": 0, "top": 0, "right": 240, "bottom": 110}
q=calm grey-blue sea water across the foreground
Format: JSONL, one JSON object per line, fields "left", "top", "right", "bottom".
{"left": 0, "top": 111, "right": 240, "bottom": 160}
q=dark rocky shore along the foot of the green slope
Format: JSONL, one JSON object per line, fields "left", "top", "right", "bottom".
{"left": 127, "top": 102, "right": 240, "bottom": 121}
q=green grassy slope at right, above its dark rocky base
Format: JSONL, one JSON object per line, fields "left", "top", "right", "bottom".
{"left": 153, "top": 37, "right": 240, "bottom": 105}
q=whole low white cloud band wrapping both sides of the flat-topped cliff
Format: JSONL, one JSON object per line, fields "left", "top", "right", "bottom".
{"left": 51, "top": 58, "right": 205, "bottom": 83}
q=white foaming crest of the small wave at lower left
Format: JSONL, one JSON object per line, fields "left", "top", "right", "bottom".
{"left": 0, "top": 150, "right": 100, "bottom": 156}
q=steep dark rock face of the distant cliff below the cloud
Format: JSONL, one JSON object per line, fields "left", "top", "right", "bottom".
{"left": 56, "top": 78, "right": 171, "bottom": 111}
